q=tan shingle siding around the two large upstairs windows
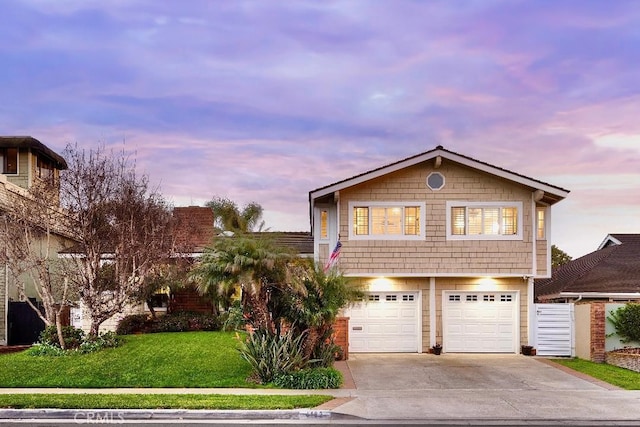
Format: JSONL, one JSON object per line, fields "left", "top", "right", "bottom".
{"left": 340, "top": 162, "right": 546, "bottom": 275}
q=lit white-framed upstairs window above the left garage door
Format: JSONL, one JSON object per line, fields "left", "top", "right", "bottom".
{"left": 349, "top": 202, "right": 425, "bottom": 240}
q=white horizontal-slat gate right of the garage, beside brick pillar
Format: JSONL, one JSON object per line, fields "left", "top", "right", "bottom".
{"left": 534, "top": 304, "right": 575, "bottom": 356}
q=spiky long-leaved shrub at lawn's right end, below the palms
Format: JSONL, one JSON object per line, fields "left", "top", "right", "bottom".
{"left": 238, "top": 330, "right": 306, "bottom": 384}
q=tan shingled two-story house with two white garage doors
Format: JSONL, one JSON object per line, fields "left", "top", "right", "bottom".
{"left": 309, "top": 146, "right": 569, "bottom": 353}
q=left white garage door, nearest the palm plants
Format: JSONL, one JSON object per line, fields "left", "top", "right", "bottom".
{"left": 347, "top": 292, "right": 421, "bottom": 353}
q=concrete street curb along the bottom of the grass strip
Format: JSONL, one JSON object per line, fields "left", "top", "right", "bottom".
{"left": 0, "top": 409, "right": 332, "bottom": 423}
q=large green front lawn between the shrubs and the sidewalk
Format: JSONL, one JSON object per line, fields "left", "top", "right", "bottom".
{"left": 0, "top": 332, "right": 257, "bottom": 388}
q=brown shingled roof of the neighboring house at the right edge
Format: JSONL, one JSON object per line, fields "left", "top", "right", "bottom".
{"left": 535, "top": 234, "right": 640, "bottom": 302}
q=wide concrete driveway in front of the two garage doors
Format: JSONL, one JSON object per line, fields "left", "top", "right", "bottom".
{"left": 333, "top": 354, "right": 640, "bottom": 425}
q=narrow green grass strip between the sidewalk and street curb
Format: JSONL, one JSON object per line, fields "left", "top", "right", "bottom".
{"left": 0, "top": 394, "right": 333, "bottom": 410}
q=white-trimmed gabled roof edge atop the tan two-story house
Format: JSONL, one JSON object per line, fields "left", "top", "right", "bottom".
{"left": 309, "top": 145, "right": 569, "bottom": 204}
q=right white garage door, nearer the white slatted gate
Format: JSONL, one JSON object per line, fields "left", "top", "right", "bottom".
{"left": 442, "top": 291, "right": 518, "bottom": 353}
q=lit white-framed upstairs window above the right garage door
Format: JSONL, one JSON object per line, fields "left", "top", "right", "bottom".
{"left": 447, "top": 202, "right": 522, "bottom": 240}
